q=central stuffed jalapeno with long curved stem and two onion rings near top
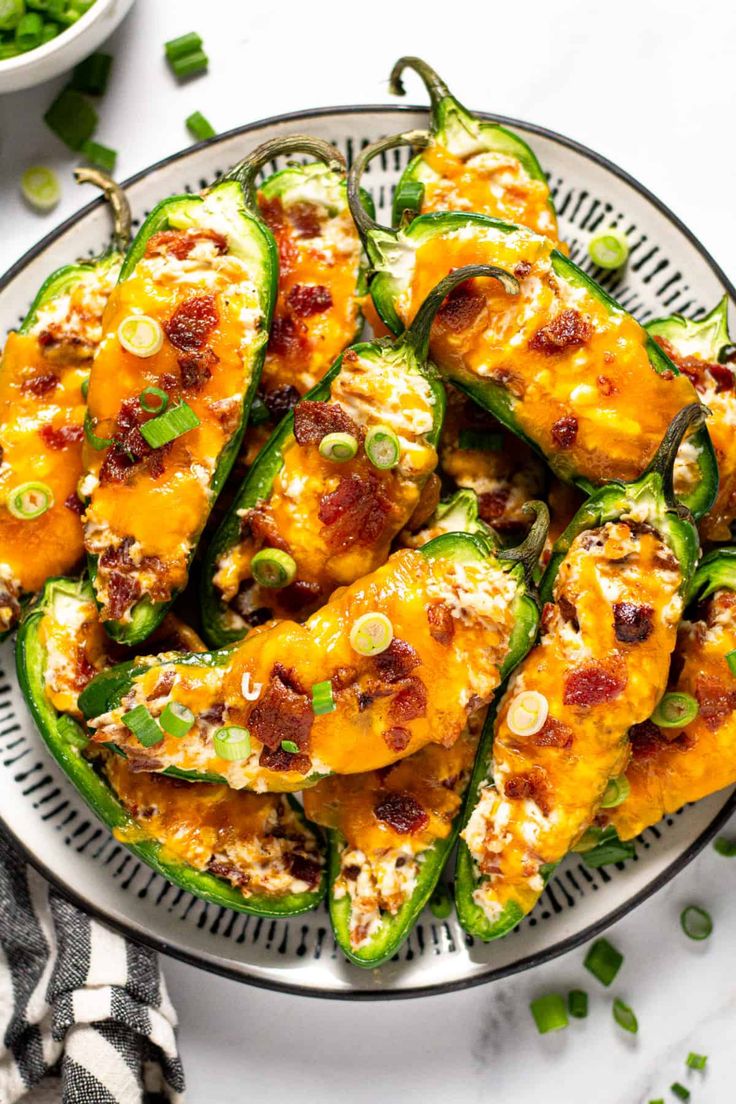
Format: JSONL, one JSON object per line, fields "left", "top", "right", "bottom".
{"left": 197, "top": 267, "right": 515, "bottom": 647}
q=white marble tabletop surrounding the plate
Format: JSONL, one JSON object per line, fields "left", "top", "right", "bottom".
{"left": 0, "top": 0, "right": 736, "bottom": 1104}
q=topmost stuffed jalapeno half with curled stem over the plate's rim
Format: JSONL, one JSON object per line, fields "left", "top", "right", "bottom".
{"left": 390, "top": 57, "right": 557, "bottom": 241}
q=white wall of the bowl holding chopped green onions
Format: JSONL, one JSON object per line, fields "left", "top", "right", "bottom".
{"left": 0, "top": 0, "right": 134, "bottom": 93}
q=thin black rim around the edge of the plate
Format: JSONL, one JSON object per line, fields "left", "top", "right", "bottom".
{"left": 0, "top": 104, "right": 736, "bottom": 1000}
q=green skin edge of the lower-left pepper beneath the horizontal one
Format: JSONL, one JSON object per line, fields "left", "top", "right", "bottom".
{"left": 15, "top": 578, "right": 327, "bottom": 917}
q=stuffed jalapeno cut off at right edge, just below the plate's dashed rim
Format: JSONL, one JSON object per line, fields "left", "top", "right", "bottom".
{"left": 647, "top": 296, "right": 736, "bottom": 541}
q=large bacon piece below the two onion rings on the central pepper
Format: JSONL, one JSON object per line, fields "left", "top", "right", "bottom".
{"left": 320, "top": 470, "right": 393, "bottom": 551}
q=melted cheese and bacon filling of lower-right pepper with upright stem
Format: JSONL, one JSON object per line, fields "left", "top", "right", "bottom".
{"left": 463, "top": 522, "right": 682, "bottom": 921}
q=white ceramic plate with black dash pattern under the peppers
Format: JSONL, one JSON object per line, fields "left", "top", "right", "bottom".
{"left": 0, "top": 107, "right": 736, "bottom": 998}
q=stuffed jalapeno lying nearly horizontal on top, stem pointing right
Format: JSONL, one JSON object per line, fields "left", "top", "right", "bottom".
{"left": 79, "top": 505, "right": 546, "bottom": 790}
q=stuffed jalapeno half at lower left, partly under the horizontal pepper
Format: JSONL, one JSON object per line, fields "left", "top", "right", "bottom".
{"left": 17, "top": 578, "right": 324, "bottom": 916}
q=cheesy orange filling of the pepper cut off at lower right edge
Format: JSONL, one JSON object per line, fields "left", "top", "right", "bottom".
{"left": 600, "top": 591, "right": 736, "bottom": 839}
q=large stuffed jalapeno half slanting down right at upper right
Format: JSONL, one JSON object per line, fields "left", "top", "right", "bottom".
{"left": 348, "top": 134, "right": 717, "bottom": 517}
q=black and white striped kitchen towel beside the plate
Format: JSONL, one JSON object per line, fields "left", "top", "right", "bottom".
{"left": 0, "top": 832, "right": 184, "bottom": 1104}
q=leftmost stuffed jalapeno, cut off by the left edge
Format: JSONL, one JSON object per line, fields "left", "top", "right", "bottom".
{"left": 0, "top": 169, "right": 130, "bottom": 635}
